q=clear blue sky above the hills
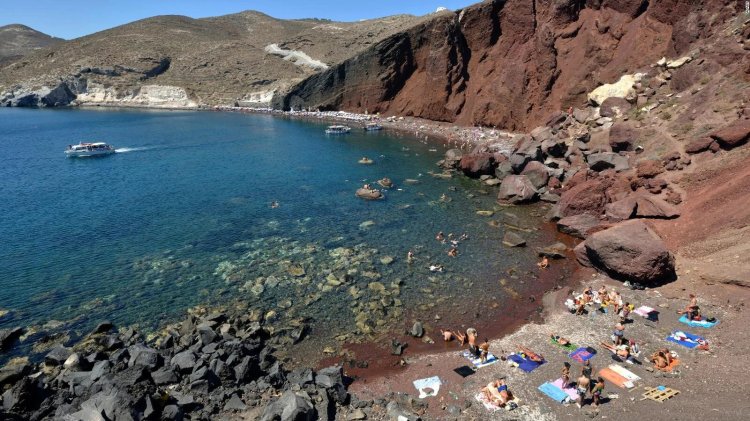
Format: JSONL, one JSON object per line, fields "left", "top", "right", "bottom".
{"left": 0, "top": 0, "right": 479, "bottom": 39}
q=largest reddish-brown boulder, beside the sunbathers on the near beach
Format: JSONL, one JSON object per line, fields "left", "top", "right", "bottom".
{"left": 579, "top": 219, "right": 675, "bottom": 284}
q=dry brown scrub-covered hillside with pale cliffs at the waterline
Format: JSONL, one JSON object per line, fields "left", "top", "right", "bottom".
{"left": 0, "top": 12, "right": 419, "bottom": 106}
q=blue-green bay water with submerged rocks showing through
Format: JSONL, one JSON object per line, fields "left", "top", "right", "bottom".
{"left": 0, "top": 109, "right": 544, "bottom": 358}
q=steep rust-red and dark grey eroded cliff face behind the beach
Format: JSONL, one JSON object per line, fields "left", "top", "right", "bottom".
{"left": 274, "top": 0, "right": 733, "bottom": 130}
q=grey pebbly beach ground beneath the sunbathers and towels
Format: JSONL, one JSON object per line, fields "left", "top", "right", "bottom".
{"left": 340, "top": 271, "right": 750, "bottom": 420}
